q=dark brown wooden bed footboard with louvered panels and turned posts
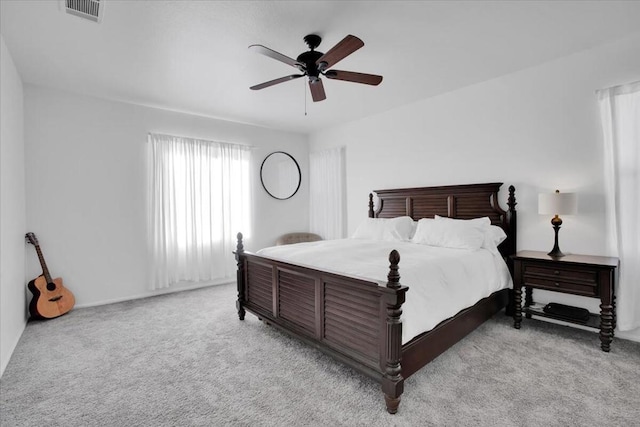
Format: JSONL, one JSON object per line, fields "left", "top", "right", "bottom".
{"left": 235, "top": 233, "right": 408, "bottom": 413}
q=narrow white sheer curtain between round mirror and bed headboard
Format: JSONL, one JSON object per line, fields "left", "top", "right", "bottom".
{"left": 309, "top": 147, "right": 346, "bottom": 239}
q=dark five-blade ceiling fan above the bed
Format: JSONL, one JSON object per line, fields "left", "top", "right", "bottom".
{"left": 249, "top": 34, "right": 382, "bottom": 102}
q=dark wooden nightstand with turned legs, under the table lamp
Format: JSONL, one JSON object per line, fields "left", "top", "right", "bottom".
{"left": 511, "top": 251, "right": 618, "bottom": 352}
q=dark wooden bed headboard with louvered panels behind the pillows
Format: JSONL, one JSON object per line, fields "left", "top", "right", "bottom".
{"left": 369, "top": 182, "right": 516, "bottom": 257}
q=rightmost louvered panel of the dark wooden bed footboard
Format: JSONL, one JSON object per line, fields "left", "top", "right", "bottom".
{"left": 324, "top": 282, "right": 381, "bottom": 363}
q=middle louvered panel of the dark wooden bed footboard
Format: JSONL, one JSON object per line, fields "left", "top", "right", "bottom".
{"left": 278, "top": 270, "right": 316, "bottom": 335}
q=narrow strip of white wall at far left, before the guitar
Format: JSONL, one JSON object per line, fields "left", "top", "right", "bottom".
{"left": 0, "top": 36, "right": 27, "bottom": 376}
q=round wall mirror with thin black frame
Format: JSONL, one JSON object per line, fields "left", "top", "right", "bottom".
{"left": 260, "top": 151, "right": 300, "bottom": 200}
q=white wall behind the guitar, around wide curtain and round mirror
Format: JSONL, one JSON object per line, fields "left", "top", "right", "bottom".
{"left": 25, "top": 85, "right": 309, "bottom": 306}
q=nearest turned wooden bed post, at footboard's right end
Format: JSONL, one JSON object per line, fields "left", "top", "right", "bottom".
{"left": 382, "top": 249, "right": 407, "bottom": 414}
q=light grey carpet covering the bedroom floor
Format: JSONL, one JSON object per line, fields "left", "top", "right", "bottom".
{"left": 0, "top": 285, "right": 640, "bottom": 426}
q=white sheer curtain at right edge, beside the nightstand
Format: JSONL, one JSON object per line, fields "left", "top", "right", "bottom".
{"left": 597, "top": 82, "right": 640, "bottom": 331}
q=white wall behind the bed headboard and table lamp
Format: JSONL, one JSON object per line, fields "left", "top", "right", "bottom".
{"left": 310, "top": 35, "right": 640, "bottom": 340}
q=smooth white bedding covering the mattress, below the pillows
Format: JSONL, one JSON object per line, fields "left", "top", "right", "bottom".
{"left": 258, "top": 239, "right": 513, "bottom": 344}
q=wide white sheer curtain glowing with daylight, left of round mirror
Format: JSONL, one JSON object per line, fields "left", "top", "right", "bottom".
{"left": 148, "top": 134, "right": 251, "bottom": 289}
